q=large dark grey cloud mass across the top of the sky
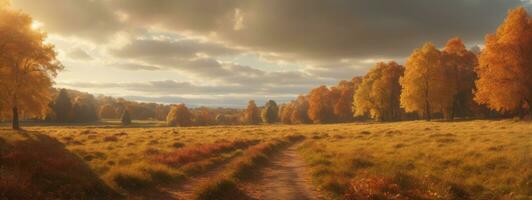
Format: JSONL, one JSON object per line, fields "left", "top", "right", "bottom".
{"left": 107, "top": 0, "right": 523, "bottom": 59}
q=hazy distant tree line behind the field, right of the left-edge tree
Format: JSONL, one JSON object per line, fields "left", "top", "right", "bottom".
{"left": 44, "top": 89, "right": 241, "bottom": 126}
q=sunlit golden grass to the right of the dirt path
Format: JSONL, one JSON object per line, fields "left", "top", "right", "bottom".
{"left": 301, "top": 121, "right": 532, "bottom": 199}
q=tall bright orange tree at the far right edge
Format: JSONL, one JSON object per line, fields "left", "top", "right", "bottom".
{"left": 475, "top": 7, "right": 532, "bottom": 117}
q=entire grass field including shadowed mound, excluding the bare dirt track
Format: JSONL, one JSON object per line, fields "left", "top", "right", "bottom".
{"left": 0, "top": 120, "right": 532, "bottom": 199}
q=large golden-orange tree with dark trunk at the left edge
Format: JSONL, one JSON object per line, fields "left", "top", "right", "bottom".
{"left": 0, "top": 5, "right": 62, "bottom": 129}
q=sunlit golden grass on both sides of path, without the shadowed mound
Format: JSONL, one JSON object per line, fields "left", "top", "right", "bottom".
{"left": 0, "top": 120, "right": 532, "bottom": 199}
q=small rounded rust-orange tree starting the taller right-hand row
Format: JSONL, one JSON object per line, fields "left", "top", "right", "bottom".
{"left": 308, "top": 86, "right": 334, "bottom": 124}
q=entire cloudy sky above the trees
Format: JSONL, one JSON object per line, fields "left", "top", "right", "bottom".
{"left": 12, "top": 0, "right": 532, "bottom": 107}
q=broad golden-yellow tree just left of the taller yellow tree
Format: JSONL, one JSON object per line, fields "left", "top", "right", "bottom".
{"left": 354, "top": 62, "right": 404, "bottom": 121}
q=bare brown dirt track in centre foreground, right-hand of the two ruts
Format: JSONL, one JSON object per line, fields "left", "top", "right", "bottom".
{"left": 243, "top": 145, "right": 323, "bottom": 200}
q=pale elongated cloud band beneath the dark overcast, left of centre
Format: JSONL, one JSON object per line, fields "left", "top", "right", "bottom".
{"left": 111, "top": 39, "right": 326, "bottom": 85}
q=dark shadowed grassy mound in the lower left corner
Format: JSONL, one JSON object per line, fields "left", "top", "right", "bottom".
{"left": 0, "top": 130, "right": 121, "bottom": 199}
